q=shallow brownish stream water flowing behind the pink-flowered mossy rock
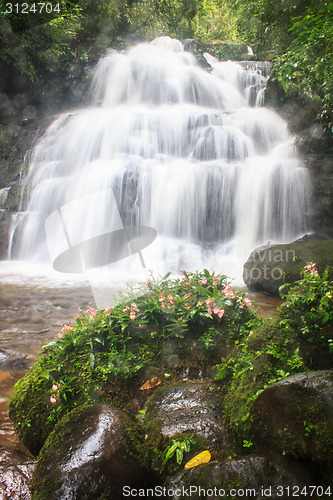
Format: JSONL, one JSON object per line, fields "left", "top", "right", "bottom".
{"left": 0, "top": 279, "right": 281, "bottom": 450}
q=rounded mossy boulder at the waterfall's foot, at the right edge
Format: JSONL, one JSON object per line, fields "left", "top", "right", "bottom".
{"left": 243, "top": 236, "right": 333, "bottom": 295}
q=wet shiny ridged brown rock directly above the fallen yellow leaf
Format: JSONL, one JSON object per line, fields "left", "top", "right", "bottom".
{"left": 147, "top": 382, "right": 224, "bottom": 448}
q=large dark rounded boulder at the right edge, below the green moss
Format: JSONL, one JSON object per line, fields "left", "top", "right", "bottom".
{"left": 250, "top": 370, "right": 333, "bottom": 467}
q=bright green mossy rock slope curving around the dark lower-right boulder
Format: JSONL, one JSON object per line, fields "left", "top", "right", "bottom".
{"left": 217, "top": 317, "right": 306, "bottom": 453}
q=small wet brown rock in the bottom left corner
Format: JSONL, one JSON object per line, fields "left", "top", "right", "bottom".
{"left": 0, "top": 446, "right": 35, "bottom": 500}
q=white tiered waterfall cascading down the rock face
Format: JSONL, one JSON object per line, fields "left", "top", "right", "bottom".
{"left": 10, "top": 37, "right": 308, "bottom": 284}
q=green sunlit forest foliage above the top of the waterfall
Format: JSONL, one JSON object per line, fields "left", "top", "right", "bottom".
{"left": 0, "top": 0, "right": 333, "bottom": 127}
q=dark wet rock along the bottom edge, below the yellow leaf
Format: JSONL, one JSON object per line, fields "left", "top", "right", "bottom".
{"left": 165, "top": 456, "right": 310, "bottom": 500}
